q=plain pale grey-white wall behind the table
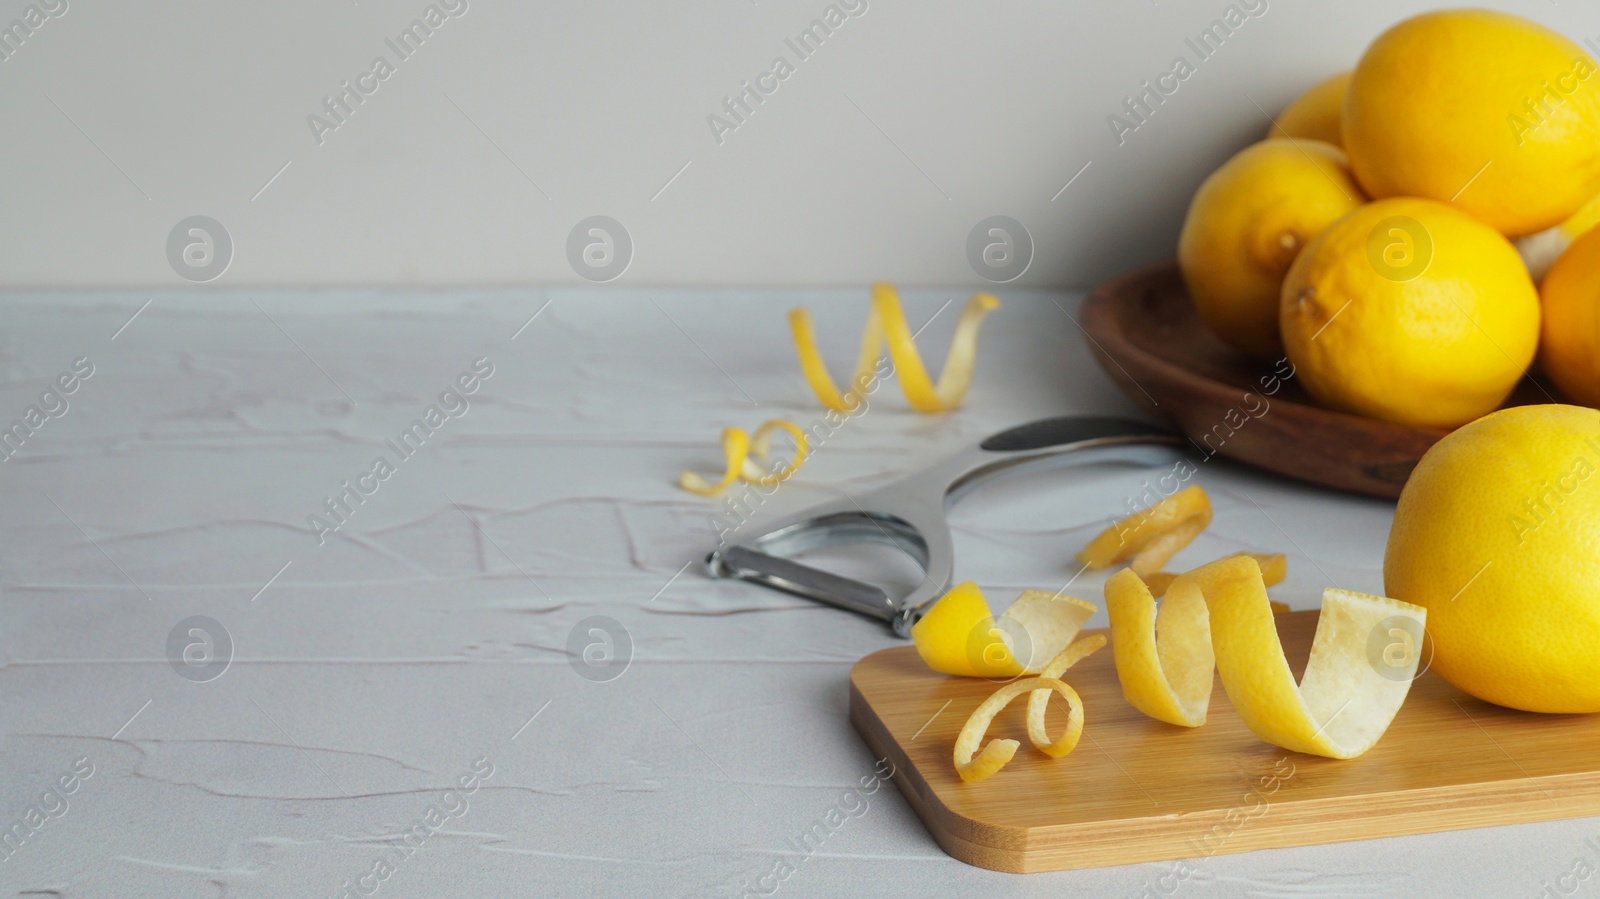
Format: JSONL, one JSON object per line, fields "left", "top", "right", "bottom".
{"left": 0, "top": 0, "right": 1600, "bottom": 286}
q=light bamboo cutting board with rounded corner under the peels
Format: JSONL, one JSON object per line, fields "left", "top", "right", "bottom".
{"left": 850, "top": 611, "right": 1600, "bottom": 877}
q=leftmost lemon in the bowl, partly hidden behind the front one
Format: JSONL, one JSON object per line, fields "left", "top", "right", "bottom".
{"left": 1178, "top": 141, "right": 1365, "bottom": 360}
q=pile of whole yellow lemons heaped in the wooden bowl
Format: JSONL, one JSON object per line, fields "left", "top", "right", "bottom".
{"left": 1178, "top": 10, "right": 1600, "bottom": 427}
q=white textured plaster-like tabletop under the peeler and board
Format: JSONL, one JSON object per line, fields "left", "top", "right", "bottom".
{"left": 0, "top": 290, "right": 1600, "bottom": 897}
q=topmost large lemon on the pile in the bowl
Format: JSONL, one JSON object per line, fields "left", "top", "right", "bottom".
{"left": 1344, "top": 10, "right": 1600, "bottom": 237}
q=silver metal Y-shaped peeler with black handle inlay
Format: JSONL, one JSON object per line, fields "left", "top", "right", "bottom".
{"left": 706, "top": 416, "right": 1184, "bottom": 637}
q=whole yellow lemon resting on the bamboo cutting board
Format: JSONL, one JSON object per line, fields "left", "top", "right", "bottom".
{"left": 1384, "top": 405, "right": 1600, "bottom": 712}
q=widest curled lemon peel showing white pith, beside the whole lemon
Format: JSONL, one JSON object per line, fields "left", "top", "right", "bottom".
{"left": 1190, "top": 557, "right": 1427, "bottom": 758}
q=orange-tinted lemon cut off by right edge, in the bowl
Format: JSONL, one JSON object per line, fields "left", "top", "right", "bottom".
{"left": 1539, "top": 229, "right": 1600, "bottom": 406}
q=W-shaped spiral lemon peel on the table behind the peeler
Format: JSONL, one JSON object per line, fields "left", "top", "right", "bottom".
{"left": 789, "top": 283, "right": 1000, "bottom": 413}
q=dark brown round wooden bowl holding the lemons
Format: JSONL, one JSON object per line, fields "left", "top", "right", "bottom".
{"left": 1080, "top": 262, "right": 1516, "bottom": 497}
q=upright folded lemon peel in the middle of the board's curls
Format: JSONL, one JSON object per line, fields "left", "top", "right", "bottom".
{"left": 1106, "top": 568, "right": 1214, "bottom": 728}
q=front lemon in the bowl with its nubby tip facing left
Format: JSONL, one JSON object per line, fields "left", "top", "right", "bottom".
{"left": 1280, "top": 198, "right": 1539, "bottom": 427}
